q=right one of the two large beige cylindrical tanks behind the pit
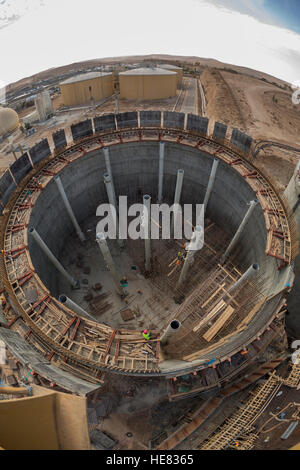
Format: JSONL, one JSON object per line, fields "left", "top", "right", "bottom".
{"left": 119, "top": 68, "right": 177, "bottom": 100}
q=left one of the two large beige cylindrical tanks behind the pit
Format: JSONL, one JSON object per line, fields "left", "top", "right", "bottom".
{"left": 60, "top": 72, "right": 113, "bottom": 106}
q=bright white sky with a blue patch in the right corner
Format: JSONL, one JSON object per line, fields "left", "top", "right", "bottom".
{"left": 0, "top": 0, "right": 300, "bottom": 88}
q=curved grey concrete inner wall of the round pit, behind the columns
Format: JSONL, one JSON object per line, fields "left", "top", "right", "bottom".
{"left": 29, "top": 142, "right": 280, "bottom": 296}
